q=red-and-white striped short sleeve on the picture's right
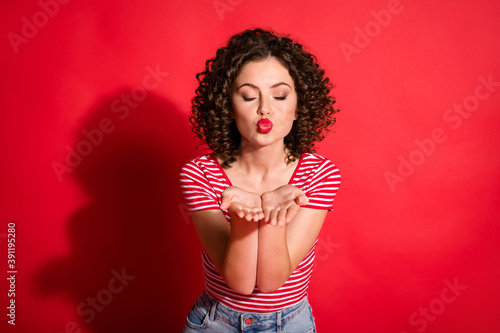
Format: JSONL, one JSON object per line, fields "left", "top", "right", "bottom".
{"left": 302, "top": 158, "right": 340, "bottom": 211}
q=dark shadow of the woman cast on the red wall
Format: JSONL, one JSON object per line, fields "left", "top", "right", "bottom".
{"left": 35, "top": 90, "right": 203, "bottom": 333}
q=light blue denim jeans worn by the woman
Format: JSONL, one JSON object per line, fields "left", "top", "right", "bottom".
{"left": 183, "top": 291, "right": 316, "bottom": 333}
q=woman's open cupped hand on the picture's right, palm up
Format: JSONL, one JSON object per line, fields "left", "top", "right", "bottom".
{"left": 261, "top": 185, "right": 309, "bottom": 227}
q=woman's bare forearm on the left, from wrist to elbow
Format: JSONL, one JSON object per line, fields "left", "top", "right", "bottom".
{"left": 221, "top": 216, "right": 258, "bottom": 295}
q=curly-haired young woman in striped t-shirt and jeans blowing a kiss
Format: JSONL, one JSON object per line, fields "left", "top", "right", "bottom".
{"left": 180, "top": 29, "right": 340, "bottom": 333}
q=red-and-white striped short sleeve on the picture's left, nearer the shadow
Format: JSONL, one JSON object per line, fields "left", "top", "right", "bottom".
{"left": 180, "top": 161, "right": 220, "bottom": 212}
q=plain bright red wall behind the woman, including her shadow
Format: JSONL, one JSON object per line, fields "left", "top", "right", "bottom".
{"left": 0, "top": 0, "right": 500, "bottom": 333}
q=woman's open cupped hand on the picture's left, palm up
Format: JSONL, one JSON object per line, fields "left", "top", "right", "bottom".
{"left": 220, "top": 186, "right": 264, "bottom": 222}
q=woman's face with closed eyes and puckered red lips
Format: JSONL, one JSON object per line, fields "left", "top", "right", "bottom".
{"left": 232, "top": 57, "right": 297, "bottom": 148}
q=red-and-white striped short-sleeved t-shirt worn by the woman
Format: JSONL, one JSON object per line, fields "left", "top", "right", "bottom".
{"left": 180, "top": 153, "right": 340, "bottom": 312}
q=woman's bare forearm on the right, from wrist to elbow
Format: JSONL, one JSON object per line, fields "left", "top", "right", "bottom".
{"left": 257, "top": 221, "right": 293, "bottom": 292}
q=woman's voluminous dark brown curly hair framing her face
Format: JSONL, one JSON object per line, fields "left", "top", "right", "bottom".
{"left": 190, "top": 29, "right": 338, "bottom": 167}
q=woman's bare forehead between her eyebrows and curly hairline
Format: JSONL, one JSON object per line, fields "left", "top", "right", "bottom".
{"left": 235, "top": 57, "right": 293, "bottom": 87}
